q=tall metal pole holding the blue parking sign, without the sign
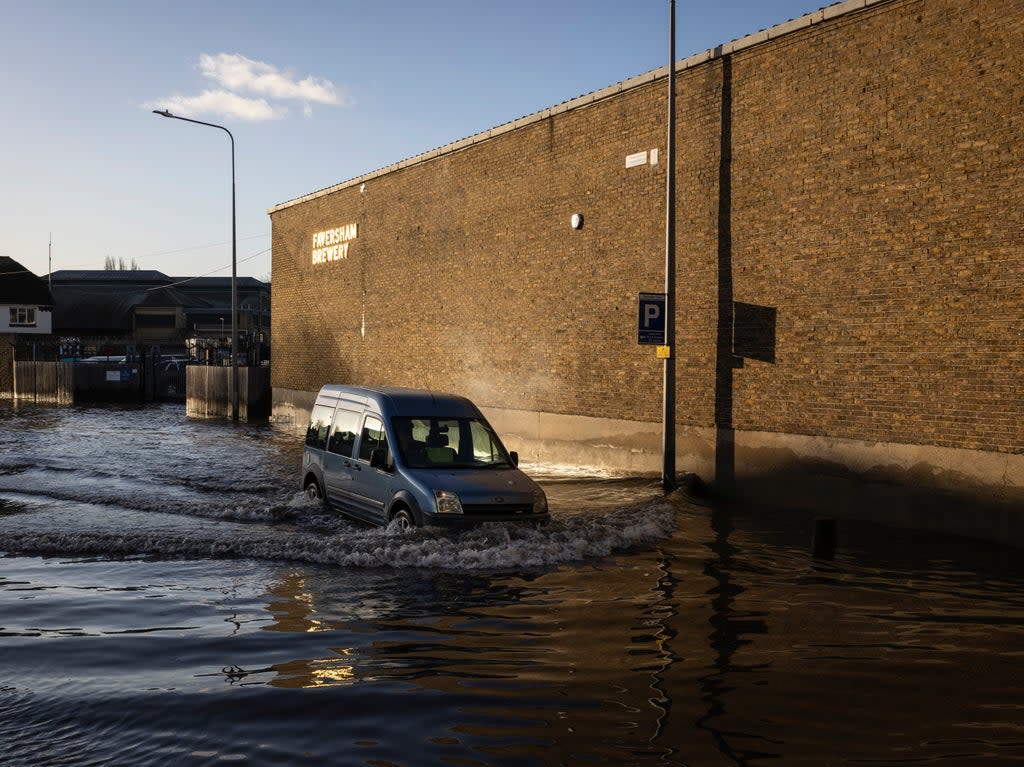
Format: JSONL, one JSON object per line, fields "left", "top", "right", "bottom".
{"left": 662, "top": 0, "right": 676, "bottom": 493}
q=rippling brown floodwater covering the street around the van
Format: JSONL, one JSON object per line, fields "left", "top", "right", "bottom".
{"left": 0, "top": 402, "right": 1024, "bottom": 767}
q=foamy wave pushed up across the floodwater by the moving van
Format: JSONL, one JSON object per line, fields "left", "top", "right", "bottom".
{"left": 0, "top": 496, "right": 675, "bottom": 570}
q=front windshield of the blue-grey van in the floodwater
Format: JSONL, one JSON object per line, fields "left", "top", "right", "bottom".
{"left": 391, "top": 416, "right": 513, "bottom": 469}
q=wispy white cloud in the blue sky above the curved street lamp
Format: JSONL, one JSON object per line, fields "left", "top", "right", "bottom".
{"left": 144, "top": 53, "right": 352, "bottom": 122}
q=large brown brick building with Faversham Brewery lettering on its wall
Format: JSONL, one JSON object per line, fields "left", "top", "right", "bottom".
{"left": 270, "top": 0, "right": 1024, "bottom": 543}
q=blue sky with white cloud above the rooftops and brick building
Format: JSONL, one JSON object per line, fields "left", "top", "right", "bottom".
{"left": 0, "top": 0, "right": 828, "bottom": 278}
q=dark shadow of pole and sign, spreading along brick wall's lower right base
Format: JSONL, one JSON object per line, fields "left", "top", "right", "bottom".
{"left": 713, "top": 61, "right": 1024, "bottom": 547}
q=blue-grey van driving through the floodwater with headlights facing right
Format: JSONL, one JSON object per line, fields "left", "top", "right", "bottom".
{"left": 301, "top": 384, "right": 548, "bottom": 528}
